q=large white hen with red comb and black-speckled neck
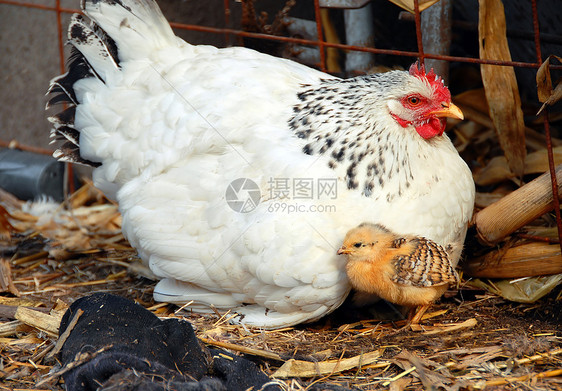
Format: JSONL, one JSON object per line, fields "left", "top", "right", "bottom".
{"left": 48, "top": 0, "right": 474, "bottom": 328}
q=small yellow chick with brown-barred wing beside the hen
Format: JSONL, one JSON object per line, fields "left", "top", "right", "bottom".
{"left": 338, "top": 223, "right": 459, "bottom": 324}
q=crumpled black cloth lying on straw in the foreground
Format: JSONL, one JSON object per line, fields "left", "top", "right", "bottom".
{"left": 60, "top": 293, "right": 281, "bottom": 391}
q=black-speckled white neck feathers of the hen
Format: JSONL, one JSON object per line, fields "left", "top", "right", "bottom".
{"left": 289, "top": 73, "right": 413, "bottom": 202}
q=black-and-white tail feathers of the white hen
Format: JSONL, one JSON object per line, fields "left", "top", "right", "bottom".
{"left": 46, "top": 0, "right": 175, "bottom": 167}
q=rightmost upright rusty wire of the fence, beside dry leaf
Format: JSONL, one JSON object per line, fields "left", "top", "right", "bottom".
{"left": 531, "top": 0, "right": 562, "bottom": 251}
